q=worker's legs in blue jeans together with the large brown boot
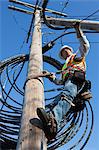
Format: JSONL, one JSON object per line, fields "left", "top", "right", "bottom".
{"left": 37, "top": 81, "right": 77, "bottom": 140}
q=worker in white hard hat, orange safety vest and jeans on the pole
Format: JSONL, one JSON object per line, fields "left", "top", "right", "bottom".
{"left": 37, "top": 22, "right": 89, "bottom": 140}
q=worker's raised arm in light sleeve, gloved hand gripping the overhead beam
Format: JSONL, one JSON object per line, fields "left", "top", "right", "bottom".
{"left": 74, "top": 22, "right": 90, "bottom": 58}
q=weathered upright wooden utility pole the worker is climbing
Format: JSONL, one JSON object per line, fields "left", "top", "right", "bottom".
{"left": 17, "top": 10, "right": 47, "bottom": 150}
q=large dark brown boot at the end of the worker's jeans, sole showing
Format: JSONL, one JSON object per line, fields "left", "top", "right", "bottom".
{"left": 37, "top": 108, "right": 57, "bottom": 141}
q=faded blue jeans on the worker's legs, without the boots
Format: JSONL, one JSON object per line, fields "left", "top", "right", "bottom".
{"left": 53, "top": 80, "right": 77, "bottom": 127}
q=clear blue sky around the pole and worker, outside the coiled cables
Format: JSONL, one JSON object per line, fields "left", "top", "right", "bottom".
{"left": 0, "top": 0, "right": 99, "bottom": 150}
